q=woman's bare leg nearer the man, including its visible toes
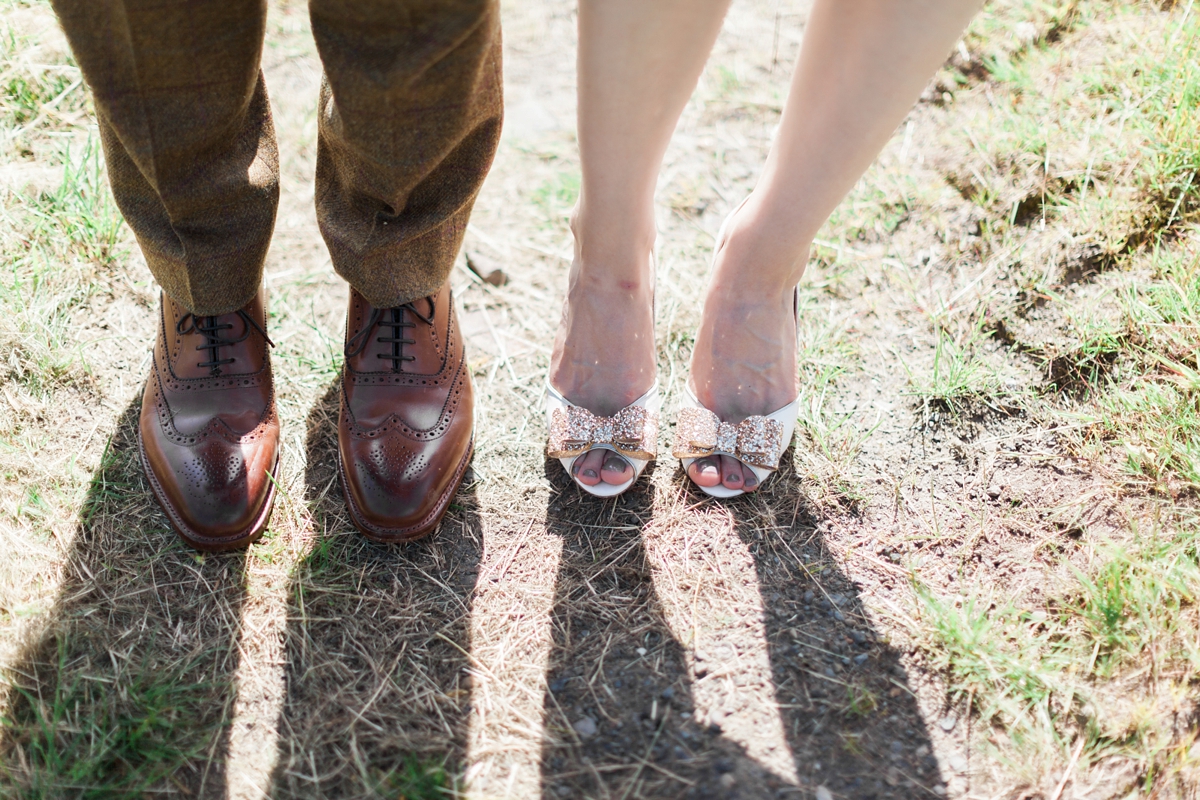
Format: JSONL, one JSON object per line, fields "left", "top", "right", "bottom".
{"left": 550, "top": 0, "right": 728, "bottom": 485}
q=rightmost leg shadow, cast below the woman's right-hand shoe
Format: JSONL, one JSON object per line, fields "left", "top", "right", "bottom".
{"left": 726, "top": 470, "right": 946, "bottom": 800}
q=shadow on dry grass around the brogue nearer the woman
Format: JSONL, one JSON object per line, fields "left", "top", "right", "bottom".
{"left": 266, "top": 380, "right": 482, "bottom": 799}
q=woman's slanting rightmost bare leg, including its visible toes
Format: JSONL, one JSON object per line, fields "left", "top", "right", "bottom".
{"left": 689, "top": 0, "right": 982, "bottom": 489}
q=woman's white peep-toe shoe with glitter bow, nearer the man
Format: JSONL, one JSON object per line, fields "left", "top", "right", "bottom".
{"left": 546, "top": 381, "right": 662, "bottom": 498}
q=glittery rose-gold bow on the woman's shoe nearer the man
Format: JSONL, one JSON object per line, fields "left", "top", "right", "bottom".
{"left": 546, "top": 405, "right": 659, "bottom": 461}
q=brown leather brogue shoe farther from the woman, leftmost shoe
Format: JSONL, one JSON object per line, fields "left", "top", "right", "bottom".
{"left": 138, "top": 289, "right": 280, "bottom": 551}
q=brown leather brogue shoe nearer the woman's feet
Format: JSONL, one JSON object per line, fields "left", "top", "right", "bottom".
{"left": 337, "top": 282, "right": 474, "bottom": 542}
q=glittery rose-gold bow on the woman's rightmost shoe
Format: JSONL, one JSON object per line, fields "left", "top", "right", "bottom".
{"left": 672, "top": 408, "right": 786, "bottom": 469}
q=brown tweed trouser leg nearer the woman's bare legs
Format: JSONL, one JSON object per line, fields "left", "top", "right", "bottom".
{"left": 308, "top": 0, "right": 503, "bottom": 308}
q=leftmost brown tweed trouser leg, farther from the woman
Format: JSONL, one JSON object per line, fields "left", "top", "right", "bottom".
{"left": 54, "top": 0, "right": 280, "bottom": 314}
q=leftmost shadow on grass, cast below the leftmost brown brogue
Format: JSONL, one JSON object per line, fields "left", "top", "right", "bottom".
{"left": 0, "top": 398, "right": 246, "bottom": 798}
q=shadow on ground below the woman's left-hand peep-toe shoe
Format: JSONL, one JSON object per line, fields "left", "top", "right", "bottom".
{"left": 541, "top": 463, "right": 784, "bottom": 800}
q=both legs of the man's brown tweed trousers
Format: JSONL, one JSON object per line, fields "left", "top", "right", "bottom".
{"left": 53, "top": 0, "right": 502, "bottom": 314}
